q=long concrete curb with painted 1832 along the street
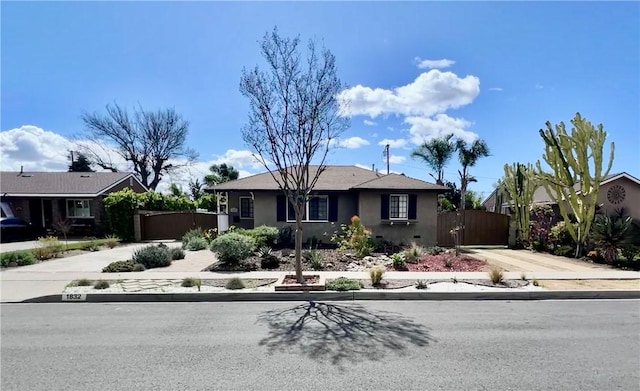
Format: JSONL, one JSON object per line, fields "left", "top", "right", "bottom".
{"left": 20, "top": 290, "right": 640, "bottom": 303}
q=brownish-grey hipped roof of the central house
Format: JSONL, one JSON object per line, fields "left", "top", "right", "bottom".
{"left": 212, "top": 166, "right": 447, "bottom": 191}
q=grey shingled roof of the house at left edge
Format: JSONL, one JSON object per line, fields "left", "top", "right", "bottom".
{"left": 0, "top": 171, "right": 144, "bottom": 197}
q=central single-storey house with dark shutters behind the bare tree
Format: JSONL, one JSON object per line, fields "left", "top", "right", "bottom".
{"left": 208, "top": 166, "right": 448, "bottom": 245}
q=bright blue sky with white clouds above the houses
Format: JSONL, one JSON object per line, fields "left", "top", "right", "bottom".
{"left": 0, "top": 2, "right": 640, "bottom": 195}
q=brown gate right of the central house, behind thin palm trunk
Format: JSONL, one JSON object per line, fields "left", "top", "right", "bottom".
{"left": 437, "top": 210, "right": 509, "bottom": 247}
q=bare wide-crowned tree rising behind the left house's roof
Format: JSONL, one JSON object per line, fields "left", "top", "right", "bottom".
{"left": 82, "top": 104, "right": 197, "bottom": 190}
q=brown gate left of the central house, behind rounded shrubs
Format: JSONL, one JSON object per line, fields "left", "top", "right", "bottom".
{"left": 140, "top": 212, "right": 218, "bottom": 240}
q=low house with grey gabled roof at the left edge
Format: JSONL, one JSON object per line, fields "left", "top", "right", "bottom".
{"left": 0, "top": 171, "right": 147, "bottom": 235}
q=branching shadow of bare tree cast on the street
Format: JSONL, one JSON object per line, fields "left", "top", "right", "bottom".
{"left": 258, "top": 302, "right": 433, "bottom": 366}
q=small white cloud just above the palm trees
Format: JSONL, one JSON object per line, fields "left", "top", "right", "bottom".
{"left": 404, "top": 114, "right": 478, "bottom": 145}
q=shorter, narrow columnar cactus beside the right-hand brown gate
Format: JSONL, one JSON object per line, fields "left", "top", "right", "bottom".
{"left": 501, "top": 163, "right": 540, "bottom": 248}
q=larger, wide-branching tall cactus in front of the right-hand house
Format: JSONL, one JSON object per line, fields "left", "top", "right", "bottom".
{"left": 536, "top": 113, "right": 615, "bottom": 257}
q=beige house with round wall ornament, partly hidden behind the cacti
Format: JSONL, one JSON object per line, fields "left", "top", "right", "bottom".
{"left": 482, "top": 172, "right": 640, "bottom": 219}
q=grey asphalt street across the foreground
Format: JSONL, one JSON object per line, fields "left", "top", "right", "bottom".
{"left": 0, "top": 300, "right": 640, "bottom": 391}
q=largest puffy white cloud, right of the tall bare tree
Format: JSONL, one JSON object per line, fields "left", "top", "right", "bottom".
{"left": 338, "top": 69, "right": 480, "bottom": 118}
